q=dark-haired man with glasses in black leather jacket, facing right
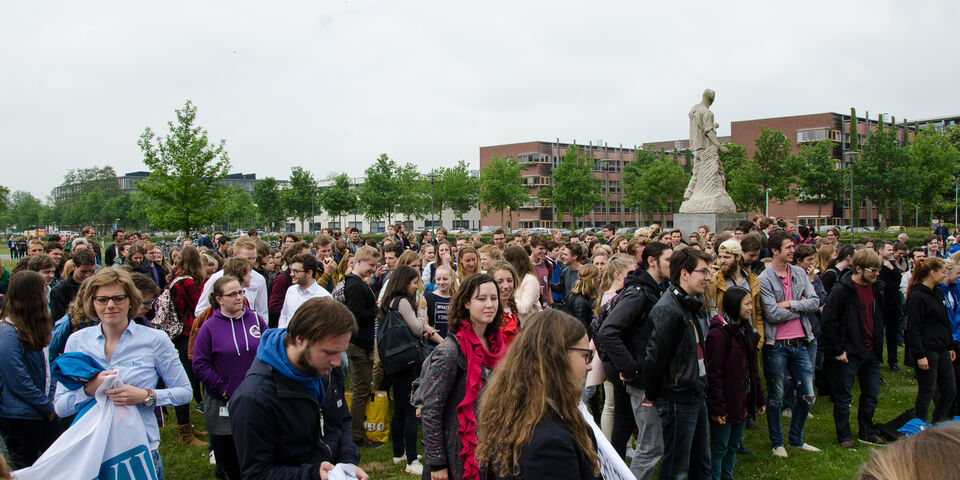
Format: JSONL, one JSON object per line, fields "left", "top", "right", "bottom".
{"left": 643, "top": 248, "right": 713, "bottom": 478}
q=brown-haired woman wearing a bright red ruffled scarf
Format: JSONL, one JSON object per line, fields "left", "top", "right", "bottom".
{"left": 421, "top": 274, "right": 506, "bottom": 480}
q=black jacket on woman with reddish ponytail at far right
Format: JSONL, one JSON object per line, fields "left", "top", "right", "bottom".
{"left": 906, "top": 283, "right": 953, "bottom": 362}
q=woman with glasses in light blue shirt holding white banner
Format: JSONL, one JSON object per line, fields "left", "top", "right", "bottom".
{"left": 54, "top": 268, "right": 193, "bottom": 479}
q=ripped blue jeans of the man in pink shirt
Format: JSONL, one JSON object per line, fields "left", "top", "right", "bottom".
{"left": 763, "top": 342, "right": 814, "bottom": 448}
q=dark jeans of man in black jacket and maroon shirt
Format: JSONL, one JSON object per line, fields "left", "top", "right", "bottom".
{"left": 830, "top": 354, "right": 880, "bottom": 443}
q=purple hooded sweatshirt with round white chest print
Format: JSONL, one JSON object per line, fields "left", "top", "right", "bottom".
{"left": 193, "top": 306, "right": 267, "bottom": 400}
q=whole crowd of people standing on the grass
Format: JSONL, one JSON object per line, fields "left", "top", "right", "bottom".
{"left": 0, "top": 216, "right": 960, "bottom": 480}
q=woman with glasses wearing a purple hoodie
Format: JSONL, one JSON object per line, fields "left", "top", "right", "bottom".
{"left": 193, "top": 275, "right": 267, "bottom": 480}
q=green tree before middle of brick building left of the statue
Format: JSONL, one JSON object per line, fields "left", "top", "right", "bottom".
{"left": 540, "top": 145, "right": 603, "bottom": 228}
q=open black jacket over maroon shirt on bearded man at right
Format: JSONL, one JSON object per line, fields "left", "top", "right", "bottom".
{"left": 820, "top": 270, "right": 883, "bottom": 361}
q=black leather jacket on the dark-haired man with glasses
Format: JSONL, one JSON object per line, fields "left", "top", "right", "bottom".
{"left": 643, "top": 284, "right": 706, "bottom": 403}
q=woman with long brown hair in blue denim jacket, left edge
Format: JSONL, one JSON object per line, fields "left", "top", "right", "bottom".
{"left": 0, "top": 270, "right": 57, "bottom": 467}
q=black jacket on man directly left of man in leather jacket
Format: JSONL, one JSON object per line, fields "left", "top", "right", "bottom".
{"left": 594, "top": 268, "right": 662, "bottom": 389}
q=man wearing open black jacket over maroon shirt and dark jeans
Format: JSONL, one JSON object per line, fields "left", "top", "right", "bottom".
{"left": 822, "top": 248, "right": 883, "bottom": 449}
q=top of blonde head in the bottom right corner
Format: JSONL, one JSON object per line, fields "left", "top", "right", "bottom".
{"left": 857, "top": 422, "right": 960, "bottom": 480}
